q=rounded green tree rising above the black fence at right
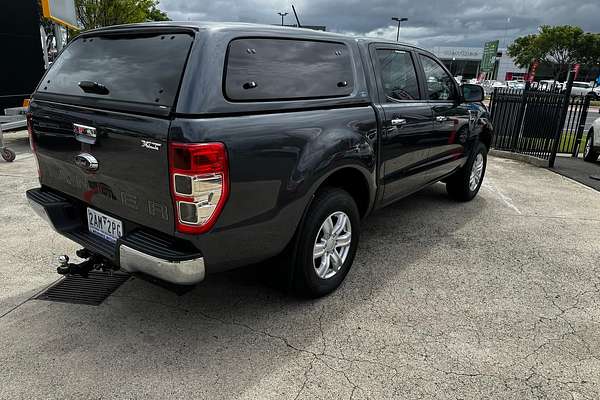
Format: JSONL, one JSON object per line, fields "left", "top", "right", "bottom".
{"left": 508, "top": 25, "right": 595, "bottom": 79}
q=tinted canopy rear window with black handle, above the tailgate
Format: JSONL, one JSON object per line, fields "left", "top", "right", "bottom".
{"left": 38, "top": 33, "right": 193, "bottom": 108}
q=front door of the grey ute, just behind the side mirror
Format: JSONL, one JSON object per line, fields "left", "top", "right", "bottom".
{"left": 419, "top": 53, "right": 469, "bottom": 177}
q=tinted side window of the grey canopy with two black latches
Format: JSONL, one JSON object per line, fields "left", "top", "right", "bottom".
{"left": 223, "top": 38, "right": 354, "bottom": 101}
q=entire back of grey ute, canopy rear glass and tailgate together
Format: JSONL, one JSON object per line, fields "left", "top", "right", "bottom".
{"left": 30, "top": 28, "right": 194, "bottom": 234}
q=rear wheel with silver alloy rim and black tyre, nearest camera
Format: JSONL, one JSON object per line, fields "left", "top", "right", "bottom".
{"left": 292, "top": 188, "right": 360, "bottom": 298}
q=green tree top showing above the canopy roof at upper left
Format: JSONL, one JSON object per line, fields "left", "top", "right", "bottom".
{"left": 75, "top": 0, "right": 169, "bottom": 30}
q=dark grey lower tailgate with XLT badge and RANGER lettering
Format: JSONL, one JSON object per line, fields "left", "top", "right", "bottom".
{"left": 30, "top": 101, "right": 174, "bottom": 234}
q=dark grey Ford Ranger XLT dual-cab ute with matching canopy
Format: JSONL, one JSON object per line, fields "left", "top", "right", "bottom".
{"left": 27, "top": 22, "right": 492, "bottom": 296}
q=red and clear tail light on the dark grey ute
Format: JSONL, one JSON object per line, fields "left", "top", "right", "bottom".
{"left": 169, "top": 143, "right": 229, "bottom": 234}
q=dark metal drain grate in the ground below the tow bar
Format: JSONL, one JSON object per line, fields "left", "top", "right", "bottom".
{"left": 36, "top": 271, "right": 129, "bottom": 306}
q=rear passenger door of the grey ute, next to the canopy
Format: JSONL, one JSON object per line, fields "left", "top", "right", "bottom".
{"left": 370, "top": 44, "right": 433, "bottom": 203}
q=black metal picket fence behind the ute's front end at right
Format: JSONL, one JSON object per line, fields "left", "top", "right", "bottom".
{"left": 490, "top": 73, "right": 590, "bottom": 167}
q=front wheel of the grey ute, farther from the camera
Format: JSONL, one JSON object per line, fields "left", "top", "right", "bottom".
{"left": 446, "top": 142, "right": 487, "bottom": 201}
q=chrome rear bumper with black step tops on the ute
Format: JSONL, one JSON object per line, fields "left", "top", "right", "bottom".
{"left": 27, "top": 189, "right": 206, "bottom": 285}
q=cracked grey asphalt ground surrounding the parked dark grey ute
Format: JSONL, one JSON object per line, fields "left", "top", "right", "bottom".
{"left": 0, "top": 133, "right": 600, "bottom": 400}
